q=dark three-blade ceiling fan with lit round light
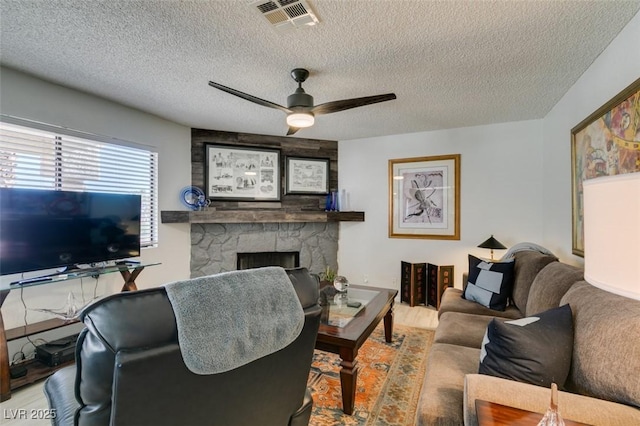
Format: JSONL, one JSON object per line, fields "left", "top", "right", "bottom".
{"left": 209, "top": 68, "right": 396, "bottom": 136}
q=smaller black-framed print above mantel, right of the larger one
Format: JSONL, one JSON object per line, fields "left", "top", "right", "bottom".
{"left": 285, "top": 157, "right": 329, "bottom": 195}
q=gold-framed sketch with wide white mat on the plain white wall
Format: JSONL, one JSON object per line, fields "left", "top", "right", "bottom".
{"left": 389, "top": 154, "right": 460, "bottom": 240}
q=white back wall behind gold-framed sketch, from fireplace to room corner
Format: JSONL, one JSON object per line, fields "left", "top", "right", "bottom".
{"left": 338, "top": 120, "right": 544, "bottom": 289}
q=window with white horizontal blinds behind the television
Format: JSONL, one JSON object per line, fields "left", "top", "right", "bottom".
{"left": 0, "top": 122, "right": 158, "bottom": 247}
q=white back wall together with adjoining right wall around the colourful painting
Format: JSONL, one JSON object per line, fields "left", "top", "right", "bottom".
{"left": 338, "top": 9, "right": 640, "bottom": 288}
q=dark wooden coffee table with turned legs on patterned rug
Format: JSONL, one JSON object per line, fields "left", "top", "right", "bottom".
{"left": 316, "top": 285, "right": 398, "bottom": 414}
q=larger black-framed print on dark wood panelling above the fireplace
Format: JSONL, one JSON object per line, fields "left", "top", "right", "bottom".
{"left": 204, "top": 144, "right": 280, "bottom": 201}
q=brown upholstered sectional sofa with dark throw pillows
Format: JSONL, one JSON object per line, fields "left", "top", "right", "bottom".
{"left": 416, "top": 250, "right": 640, "bottom": 426}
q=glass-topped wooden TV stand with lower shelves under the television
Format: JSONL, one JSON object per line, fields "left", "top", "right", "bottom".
{"left": 0, "top": 262, "right": 159, "bottom": 401}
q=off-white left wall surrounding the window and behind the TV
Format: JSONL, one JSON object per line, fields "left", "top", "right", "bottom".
{"left": 0, "top": 68, "right": 191, "bottom": 334}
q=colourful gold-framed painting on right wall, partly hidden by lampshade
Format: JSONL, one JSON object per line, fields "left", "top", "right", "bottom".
{"left": 571, "top": 79, "right": 640, "bottom": 256}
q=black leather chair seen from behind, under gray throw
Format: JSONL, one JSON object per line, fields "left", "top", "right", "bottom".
{"left": 44, "top": 268, "right": 321, "bottom": 426}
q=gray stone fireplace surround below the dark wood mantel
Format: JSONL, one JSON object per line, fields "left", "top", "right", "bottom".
{"left": 191, "top": 222, "right": 339, "bottom": 278}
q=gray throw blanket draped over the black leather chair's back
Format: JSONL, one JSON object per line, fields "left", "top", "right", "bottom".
{"left": 165, "top": 267, "right": 304, "bottom": 374}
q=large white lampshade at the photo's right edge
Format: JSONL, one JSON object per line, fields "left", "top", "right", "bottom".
{"left": 583, "top": 173, "right": 640, "bottom": 300}
